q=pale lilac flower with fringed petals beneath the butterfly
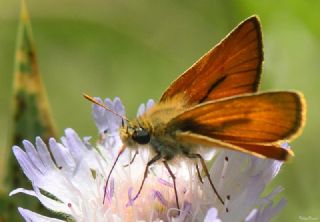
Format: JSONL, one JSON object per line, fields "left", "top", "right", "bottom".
{"left": 10, "top": 98, "right": 290, "bottom": 222}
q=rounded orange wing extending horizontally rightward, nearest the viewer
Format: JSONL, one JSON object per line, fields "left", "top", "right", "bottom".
{"left": 168, "top": 92, "right": 305, "bottom": 145}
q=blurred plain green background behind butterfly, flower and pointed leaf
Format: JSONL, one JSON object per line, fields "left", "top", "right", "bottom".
{"left": 0, "top": 0, "right": 320, "bottom": 221}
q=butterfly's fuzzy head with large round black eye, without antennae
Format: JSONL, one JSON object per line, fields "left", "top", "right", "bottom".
{"left": 120, "top": 121, "right": 151, "bottom": 147}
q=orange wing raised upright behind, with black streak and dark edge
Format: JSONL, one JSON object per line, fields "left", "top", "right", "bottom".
{"left": 160, "top": 16, "right": 263, "bottom": 104}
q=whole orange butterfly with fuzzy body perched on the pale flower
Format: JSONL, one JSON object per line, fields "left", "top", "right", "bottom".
{"left": 84, "top": 16, "right": 306, "bottom": 212}
